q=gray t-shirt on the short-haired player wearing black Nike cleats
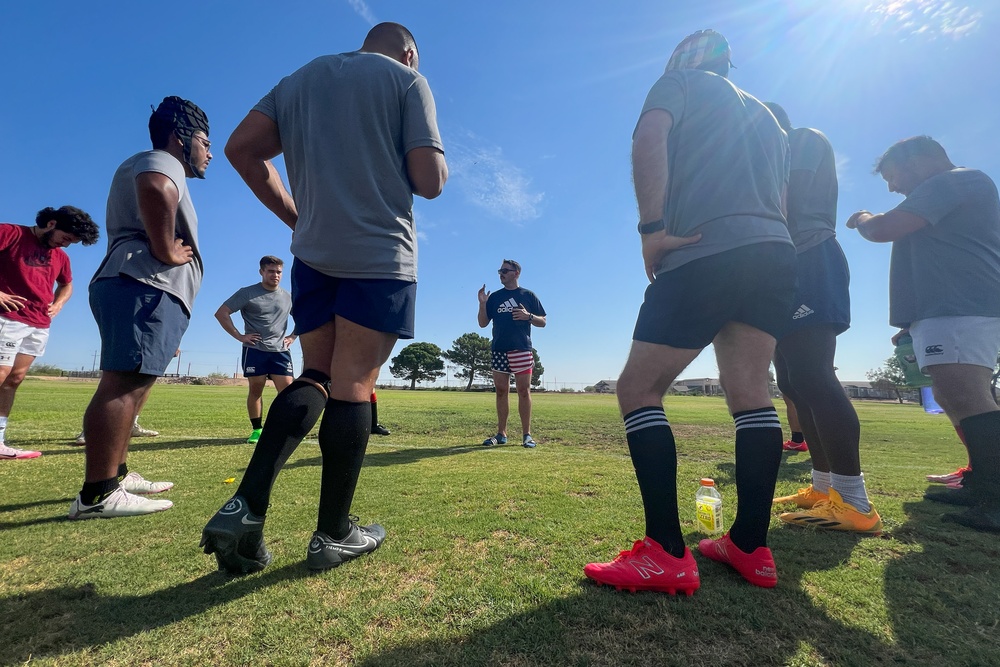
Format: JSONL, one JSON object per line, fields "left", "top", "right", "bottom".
{"left": 254, "top": 51, "right": 443, "bottom": 282}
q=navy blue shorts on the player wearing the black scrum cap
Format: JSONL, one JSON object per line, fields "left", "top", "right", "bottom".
{"left": 90, "top": 276, "right": 191, "bottom": 375}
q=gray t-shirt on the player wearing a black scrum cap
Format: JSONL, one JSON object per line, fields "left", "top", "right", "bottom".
{"left": 91, "top": 150, "right": 205, "bottom": 316}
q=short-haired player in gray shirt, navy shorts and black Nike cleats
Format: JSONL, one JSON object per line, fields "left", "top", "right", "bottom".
{"left": 201, "top": 23, "right": 448, "bottom": 573}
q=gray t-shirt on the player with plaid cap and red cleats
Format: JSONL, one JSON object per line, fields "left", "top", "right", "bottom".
{"left": 642, "top": 70, "right": 791, "bottom": 273}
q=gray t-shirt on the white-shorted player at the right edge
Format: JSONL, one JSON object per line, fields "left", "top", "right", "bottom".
{"left": 889, "top": 168, "right": 1000, "bottom": 327}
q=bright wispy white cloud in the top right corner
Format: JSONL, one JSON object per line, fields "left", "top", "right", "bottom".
{"left": 865, "top": 0, "right": 983, "bottom": 39}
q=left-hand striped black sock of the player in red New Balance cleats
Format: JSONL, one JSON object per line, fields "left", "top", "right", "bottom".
{"left": 625, "top": 407, "right": 684, "bottom": 558}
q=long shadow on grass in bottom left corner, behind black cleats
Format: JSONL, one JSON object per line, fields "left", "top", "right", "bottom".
{"left": 0, "top": 563, "right": 308, "bottom": 665}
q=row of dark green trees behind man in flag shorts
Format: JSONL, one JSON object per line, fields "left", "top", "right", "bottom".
{"left": 389, "top": 332, "right": 545, "bottom": 391}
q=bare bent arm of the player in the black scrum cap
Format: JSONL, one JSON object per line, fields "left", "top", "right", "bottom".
{"left": 135, "top": 171, "right": 194, "bottom": 266}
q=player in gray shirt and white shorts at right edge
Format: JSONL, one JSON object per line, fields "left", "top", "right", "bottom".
{"left": 847, "top": 136, "right": 1000, "bottom": 532}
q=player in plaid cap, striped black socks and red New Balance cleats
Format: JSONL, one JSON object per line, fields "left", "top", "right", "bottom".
{"left": 584, "top": 30, "right": 795, "bottom": 594}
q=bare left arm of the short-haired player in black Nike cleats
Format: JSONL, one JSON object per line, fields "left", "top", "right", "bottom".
{"left": 226, "top": 111, "right": 299, "bottom": 230}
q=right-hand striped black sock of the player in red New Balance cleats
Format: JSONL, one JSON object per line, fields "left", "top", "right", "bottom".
{"left": 729, "top": 407, "right": 781, "bottom": 553}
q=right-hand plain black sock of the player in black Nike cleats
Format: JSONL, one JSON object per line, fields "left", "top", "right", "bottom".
{"left": 316, "top": 398, "right": 372, "bottom": 540}
